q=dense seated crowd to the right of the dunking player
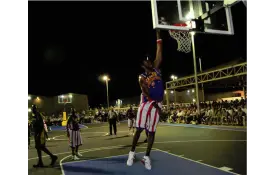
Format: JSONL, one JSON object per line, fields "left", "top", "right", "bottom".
{"left": 160, "top": 99, "right": 247, "bottom": 126}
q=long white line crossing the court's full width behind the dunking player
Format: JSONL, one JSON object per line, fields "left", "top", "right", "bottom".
{"left": 28, "top": 140, "right": 247, "bottom": 160}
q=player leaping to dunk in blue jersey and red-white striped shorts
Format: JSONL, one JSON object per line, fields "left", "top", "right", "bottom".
{"left": 127, "top": 31, "right": 164, "bottom": 170}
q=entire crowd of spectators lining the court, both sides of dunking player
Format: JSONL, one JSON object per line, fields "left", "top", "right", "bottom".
{"left": 34, "top": 99, "right": 247, "bottom": 126}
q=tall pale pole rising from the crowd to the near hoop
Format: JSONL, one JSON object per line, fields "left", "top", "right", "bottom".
{"left": 190, "top": 32, "right": 200, "bottom": 114}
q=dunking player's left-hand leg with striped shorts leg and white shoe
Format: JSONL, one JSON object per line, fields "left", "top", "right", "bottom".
{"left": 127, "top": 102, "right": 150, "bottom": 166}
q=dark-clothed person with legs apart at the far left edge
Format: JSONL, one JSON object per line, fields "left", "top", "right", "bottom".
{"left": 32, "top": 105, "right": 57, "bottom": 168}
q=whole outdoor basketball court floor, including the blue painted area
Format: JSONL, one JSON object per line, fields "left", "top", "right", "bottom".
{"left": 28, "top": 123, "right": 247, "bottom": 175}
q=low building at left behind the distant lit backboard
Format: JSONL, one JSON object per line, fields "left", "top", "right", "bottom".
{"left": 28, "top": 93, "right": 89, "bottom": 115}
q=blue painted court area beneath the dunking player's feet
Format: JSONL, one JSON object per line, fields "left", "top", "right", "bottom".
{"left": 63, "top": 151, "right": 235, "bottom": 175}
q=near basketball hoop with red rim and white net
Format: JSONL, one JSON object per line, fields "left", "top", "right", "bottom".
{"left": 169, "top": 23, "right": 192, "bottom": 53}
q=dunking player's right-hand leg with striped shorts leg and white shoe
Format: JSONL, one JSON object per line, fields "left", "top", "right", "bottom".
{"left": 142, "top": 104, "right": 159, "bottom": 170}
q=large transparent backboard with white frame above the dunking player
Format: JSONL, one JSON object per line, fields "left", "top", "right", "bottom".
{"left": 151, "top": 0, "right": 238, "bottom": 35}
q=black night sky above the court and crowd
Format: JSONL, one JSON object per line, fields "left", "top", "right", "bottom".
{"left": 25, "top": 1, "right": 247, "bottom": 106}
